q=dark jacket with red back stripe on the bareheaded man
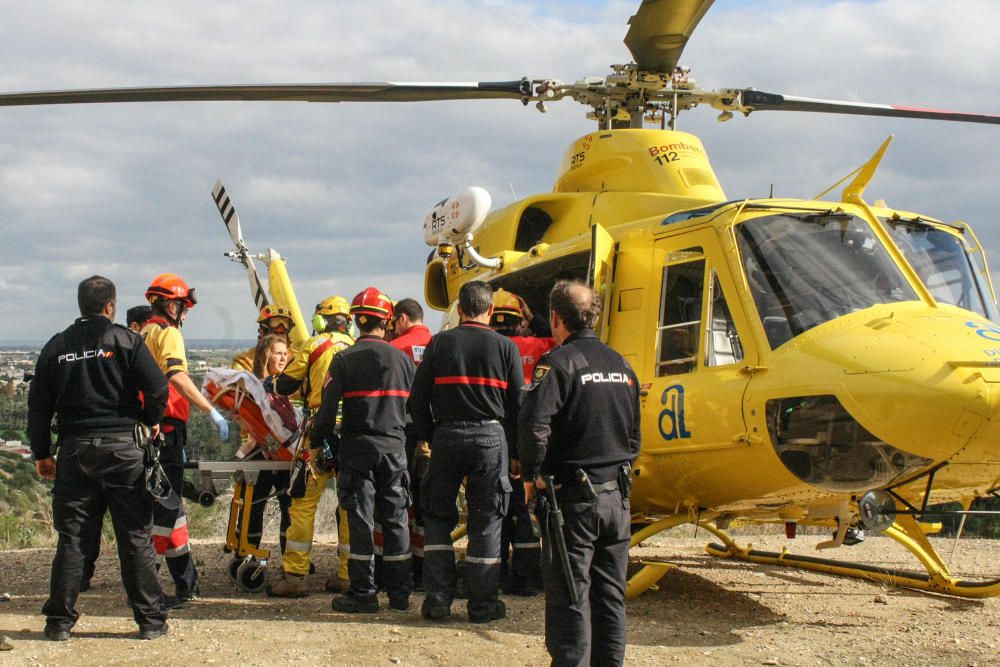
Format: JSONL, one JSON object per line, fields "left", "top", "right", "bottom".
{"left": 410, "top": 322, "right": 524, "bottom": 445}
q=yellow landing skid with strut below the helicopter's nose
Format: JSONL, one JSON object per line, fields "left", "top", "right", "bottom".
{"left": 701, "top": 516, "right": 1000, "bottom": 598}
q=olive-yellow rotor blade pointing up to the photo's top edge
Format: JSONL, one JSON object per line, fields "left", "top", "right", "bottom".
{"left": 625, "top": 0, "right": 713, "bottom": 74}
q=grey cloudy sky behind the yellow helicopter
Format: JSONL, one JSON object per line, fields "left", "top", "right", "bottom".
{"left": 0, "top": 0, "right": 1000, "bottom": 341}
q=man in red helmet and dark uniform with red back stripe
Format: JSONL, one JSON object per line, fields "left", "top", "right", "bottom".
{"left": 310, "top": 287, "right": 413, "bottom": 613}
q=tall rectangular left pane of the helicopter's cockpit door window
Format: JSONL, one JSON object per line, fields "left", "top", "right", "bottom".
{"left": 656, "top": 259, "right": 705, "bottom": 377}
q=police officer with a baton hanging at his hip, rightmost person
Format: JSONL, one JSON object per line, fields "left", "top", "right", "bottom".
{"left": 518, "top": 281, "right": 639, "bottom": 665}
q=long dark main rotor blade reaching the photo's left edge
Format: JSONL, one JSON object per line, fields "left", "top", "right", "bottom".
{"left": 0, "top": 79, "right": 532, "bottom": 106}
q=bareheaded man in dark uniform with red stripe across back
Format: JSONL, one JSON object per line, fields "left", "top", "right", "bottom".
{"left": 409, "top": 280, "right": 524, "bottom": 623}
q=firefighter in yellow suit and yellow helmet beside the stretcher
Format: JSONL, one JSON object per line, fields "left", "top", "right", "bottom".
{"left": 267, "top": 296, "right": 354, "bottom": 597}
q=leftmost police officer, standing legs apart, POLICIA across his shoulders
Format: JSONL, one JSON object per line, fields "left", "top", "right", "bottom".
{"left": 28, "top": 276, "right": 167, "bottom": 641}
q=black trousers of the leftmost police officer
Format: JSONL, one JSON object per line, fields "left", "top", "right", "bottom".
{"left": 42, "top": 434, "right": 167, "bottom": 630}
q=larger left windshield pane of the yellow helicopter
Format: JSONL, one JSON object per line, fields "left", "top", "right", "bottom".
{"left": 737, "top": 212, "right": 917, "bottom": 349}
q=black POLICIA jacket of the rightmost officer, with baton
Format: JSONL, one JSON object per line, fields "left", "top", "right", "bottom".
{"left": 518, "top": 329, "right": 640, "bottom": 484}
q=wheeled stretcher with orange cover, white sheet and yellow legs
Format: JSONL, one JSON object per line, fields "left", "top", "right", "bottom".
{"left": 191, "top": 369, "right": 302, "bottom": 593}
